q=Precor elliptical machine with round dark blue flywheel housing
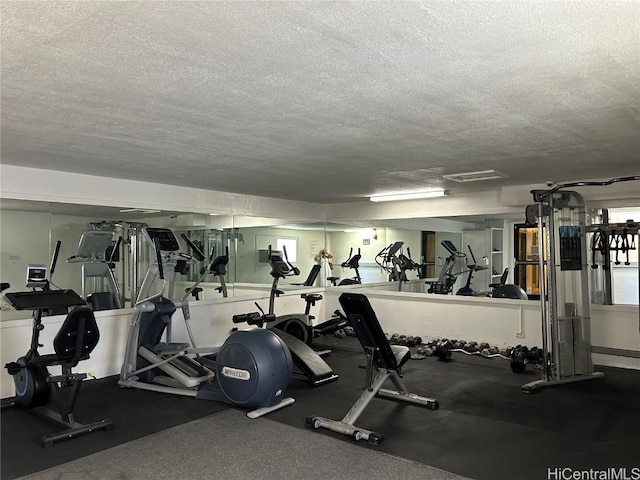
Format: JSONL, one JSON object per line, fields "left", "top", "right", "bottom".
{"left": 118, "top": 227, "right": 294, "bottom": 418}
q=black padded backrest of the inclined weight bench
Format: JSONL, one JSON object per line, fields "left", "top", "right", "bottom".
{"left": 338, "top": 292, "right": 398, "bottom": 370}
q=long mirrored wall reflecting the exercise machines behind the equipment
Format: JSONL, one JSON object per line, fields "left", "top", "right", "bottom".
{"left": 0, "top": 199, "right": 637, "bottom": 320}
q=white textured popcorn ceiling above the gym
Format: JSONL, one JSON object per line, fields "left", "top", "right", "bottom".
{"left": 0, "top": 0, "right": 640, "bottom": 203}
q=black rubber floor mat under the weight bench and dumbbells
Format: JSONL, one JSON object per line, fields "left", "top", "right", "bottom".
{"left": 270, "top": 338, "right": 640, "bottom": 480}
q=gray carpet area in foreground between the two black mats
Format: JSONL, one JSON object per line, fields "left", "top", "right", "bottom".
{"left": 21, "top": 409, "right": 464, "bottom": 480}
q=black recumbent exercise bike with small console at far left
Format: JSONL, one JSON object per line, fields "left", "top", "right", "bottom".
{"left": 2, "top": 246, "right": 112, "bottom": 447}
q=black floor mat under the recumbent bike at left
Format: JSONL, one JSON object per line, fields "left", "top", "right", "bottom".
{"left": 0, "top": 380, "right": 227, "bottom": 480}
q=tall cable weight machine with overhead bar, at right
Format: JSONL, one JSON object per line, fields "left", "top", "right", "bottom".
{"left": 521, "top": 176, "right": 640, "bottom": 393}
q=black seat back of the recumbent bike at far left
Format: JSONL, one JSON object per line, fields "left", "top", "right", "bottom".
{"left": 53, "top": 306, "right": 100, "bottom": 367}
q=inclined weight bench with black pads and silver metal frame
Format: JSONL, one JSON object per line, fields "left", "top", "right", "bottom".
{"left": 305, "top": 293, "right": 440, "bottom": 445}
